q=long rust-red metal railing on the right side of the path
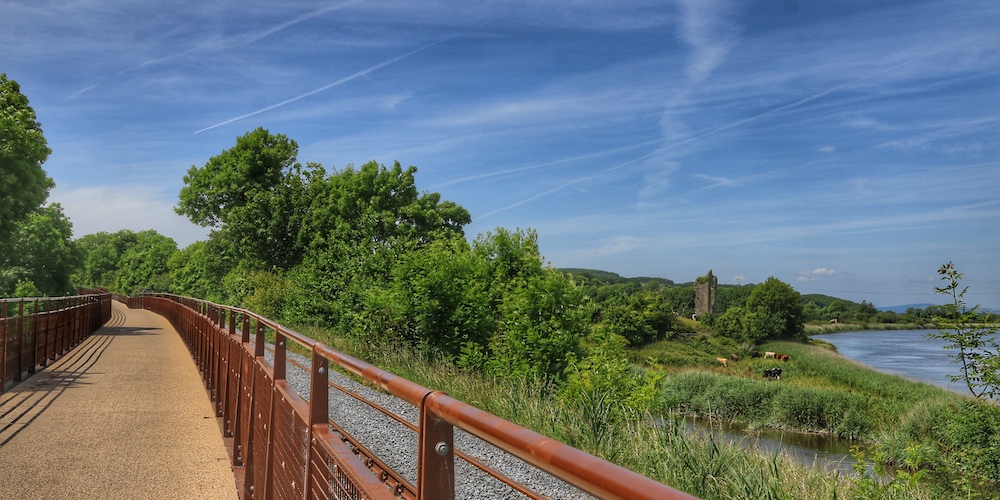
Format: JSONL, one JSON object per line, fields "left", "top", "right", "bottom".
{"left": 122, "top": 294, "right": 693, "bottom": 499}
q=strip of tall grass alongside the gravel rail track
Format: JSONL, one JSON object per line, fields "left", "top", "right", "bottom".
{"left": 300, "top": 330, "right": 922, "bottom": 499}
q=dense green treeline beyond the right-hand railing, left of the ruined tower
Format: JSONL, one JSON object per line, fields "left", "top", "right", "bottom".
{"left": 77, "top": 129, "right": 592, "bottom": 380}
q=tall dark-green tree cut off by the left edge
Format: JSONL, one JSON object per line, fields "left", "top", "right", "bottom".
{"left": 0, "top": 73, "right": 55, "bottom": 253}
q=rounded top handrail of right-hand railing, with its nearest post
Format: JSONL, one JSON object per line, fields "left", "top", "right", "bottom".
{"left": 131, "top": 293, "right": 694, "bottom": 499}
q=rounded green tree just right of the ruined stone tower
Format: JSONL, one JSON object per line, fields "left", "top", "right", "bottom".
{"left": 744, "top": 277, "right": 806, "bottom": 342}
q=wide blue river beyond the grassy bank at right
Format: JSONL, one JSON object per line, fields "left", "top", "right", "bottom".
{"left": 812, "top": 330, "right": 969, "bottom": 395}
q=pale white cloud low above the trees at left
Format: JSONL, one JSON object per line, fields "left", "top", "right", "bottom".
{"left": 48, "top": 185, "right": 208, "bottom": 248}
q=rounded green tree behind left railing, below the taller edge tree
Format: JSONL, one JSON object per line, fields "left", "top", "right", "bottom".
{"left": 8, "top": 203, "right": 83, "bottom": 295}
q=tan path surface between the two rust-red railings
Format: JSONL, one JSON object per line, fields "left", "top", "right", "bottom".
{"left": 0, "top": 302, "right": 238, "bottom": 499}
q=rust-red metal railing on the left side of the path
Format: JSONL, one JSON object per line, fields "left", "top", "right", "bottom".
{"left": 0, "top": 293, "right": 111, "bottom": 392}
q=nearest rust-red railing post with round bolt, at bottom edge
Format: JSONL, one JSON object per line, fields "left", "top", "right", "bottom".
{"left": 417, "top": 391, "right": 455, "bottom": 500}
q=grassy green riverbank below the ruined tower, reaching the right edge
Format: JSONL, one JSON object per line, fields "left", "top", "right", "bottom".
{"left": 632, "top": 333, "right": 1000, "bottom": 496}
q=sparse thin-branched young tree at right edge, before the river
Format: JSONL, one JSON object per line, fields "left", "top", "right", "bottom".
{"left": 927, "top": 262, "right": 1000, "bottom": 399}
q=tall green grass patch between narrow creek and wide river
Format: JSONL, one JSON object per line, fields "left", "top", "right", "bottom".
{"left": 665, "top": 342, "right": 962, "bottom": 442}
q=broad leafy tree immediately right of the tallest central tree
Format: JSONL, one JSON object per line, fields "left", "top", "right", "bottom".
{"left": 291, "top": 161, "right": 471, "bottom": 324}
